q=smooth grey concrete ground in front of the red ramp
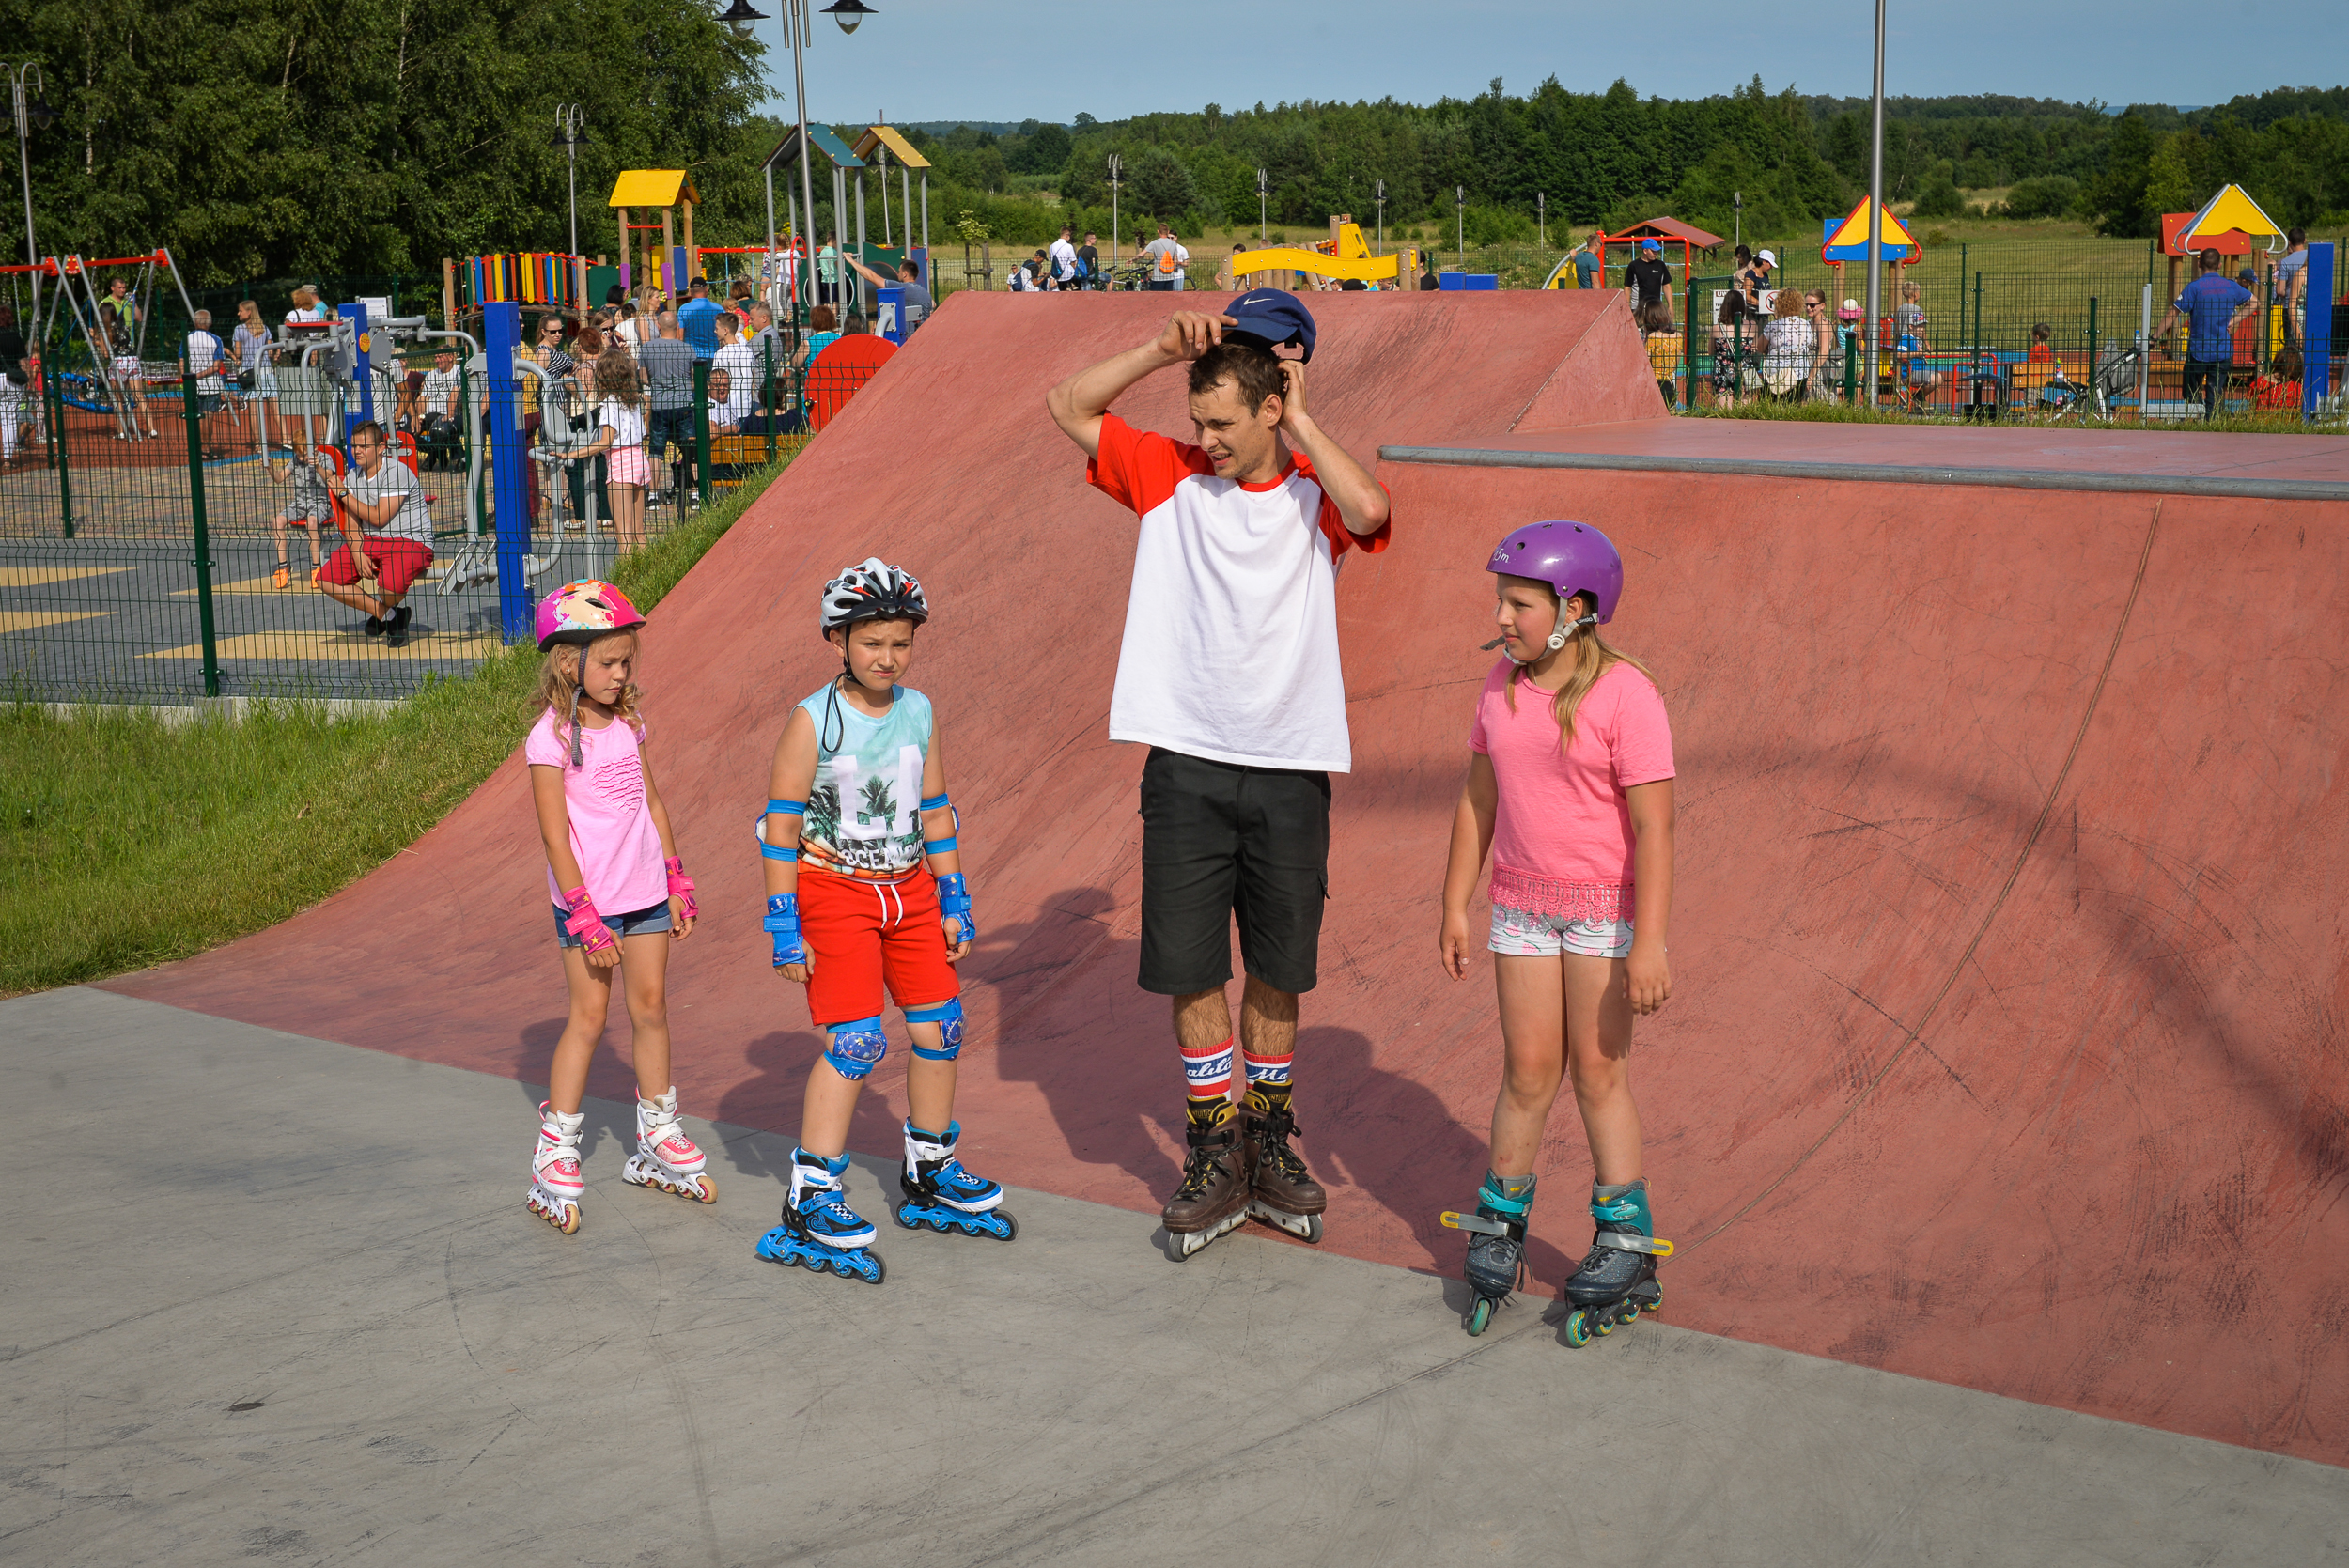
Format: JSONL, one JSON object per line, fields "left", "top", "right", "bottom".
{"left": 0, "top": 990, "right": 2349, "bottom": 1568}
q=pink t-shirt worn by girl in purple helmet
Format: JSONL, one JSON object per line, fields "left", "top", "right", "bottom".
{"left": 1469, "top": 660, "right": 1672, "bottom": 920}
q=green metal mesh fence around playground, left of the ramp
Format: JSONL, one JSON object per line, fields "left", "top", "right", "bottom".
{"left": 0, "top": 334, "right": 872, "bottom": 705}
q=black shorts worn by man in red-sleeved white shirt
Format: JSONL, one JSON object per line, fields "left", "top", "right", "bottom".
{"left": 1142, "top": 747, "right": 1330, "bottom": 995}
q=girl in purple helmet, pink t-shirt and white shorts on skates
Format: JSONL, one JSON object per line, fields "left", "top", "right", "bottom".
{"left": 1438, "top": 521, "right": 1672, "bottom": 1345}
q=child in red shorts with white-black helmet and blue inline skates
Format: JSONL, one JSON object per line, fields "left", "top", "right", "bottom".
{"left": 759, "top": 556, "right": 1018, "bottom": 1284}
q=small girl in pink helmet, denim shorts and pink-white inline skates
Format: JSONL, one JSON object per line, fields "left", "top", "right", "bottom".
{"left": 521, "top": 580, "right": 719, "bottom": 1234}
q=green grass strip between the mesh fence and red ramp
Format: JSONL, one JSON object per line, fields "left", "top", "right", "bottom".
{"left": 0, "top": 465, "right": 783, "bottom": 995}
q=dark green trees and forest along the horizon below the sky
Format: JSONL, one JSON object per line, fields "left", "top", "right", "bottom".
{"left": 0, "top": 0, "right": 2349, "bottom": 287}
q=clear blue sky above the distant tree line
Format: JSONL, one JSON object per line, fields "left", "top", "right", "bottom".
{"left": 754, "top": 0, "right": 2349, "bottom": 124}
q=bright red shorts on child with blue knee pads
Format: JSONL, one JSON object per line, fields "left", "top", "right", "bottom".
{"left": 799, "top": 863, "right": 963, "bottom": 1028}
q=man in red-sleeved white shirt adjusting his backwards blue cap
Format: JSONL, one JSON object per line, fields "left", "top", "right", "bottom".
{"left": 1046, "top": 288, "right": 1389, "bottom": 1258}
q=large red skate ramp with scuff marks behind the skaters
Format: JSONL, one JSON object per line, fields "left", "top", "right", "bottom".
{"left": 105, "top": 293, "right": 2349, "bottom": 1463}
